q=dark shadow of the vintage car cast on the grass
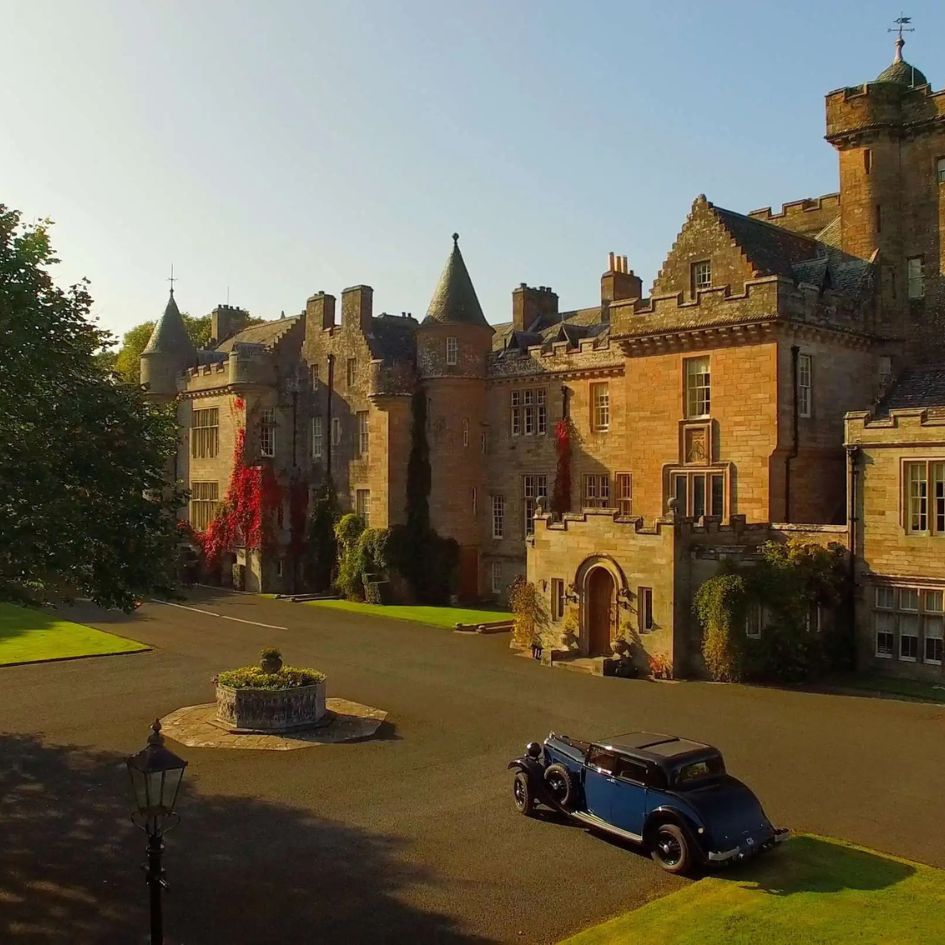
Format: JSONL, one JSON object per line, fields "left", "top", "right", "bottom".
{"left": 715, "top": 836, "right": 915, "bottom": 896}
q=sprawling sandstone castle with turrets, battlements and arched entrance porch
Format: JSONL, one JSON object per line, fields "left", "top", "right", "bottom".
{"left": 141, "top": 35, "right": 945, "bottom": 679}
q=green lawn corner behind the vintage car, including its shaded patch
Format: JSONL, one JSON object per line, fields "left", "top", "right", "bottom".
{"left": 564, "top": 836, "right": 945, "bottom": 945}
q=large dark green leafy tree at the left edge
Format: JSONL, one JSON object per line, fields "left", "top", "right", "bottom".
{"left": 0, "top": 205, "right": 180, "bottom": 609}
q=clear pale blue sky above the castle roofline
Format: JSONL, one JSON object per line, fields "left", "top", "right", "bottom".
{"left": 0, "top": 0, "right": 945, "bottom": 340}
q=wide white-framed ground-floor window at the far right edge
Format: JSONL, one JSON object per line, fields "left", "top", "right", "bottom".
{"left": 873, "top": 585, "right": 945, "bottom": 666}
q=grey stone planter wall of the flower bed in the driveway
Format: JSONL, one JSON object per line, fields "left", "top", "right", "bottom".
{"left": 217, "top": 680, "right": 326, "bottom": 733}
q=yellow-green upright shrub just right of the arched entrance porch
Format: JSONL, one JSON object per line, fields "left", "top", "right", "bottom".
{"left": 693, "top": 574, "right": 748, "bottom": 682}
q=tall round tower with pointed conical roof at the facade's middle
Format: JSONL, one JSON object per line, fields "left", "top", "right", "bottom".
{"left": 417, "top": 233, "right": 493, "bottom": 598}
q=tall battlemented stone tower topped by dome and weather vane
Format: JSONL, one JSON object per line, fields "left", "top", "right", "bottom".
{"left": 827, "top": 24, "right": 945, "bottom": 360}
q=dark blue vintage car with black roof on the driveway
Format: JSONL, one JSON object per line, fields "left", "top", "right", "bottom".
{"left": 509, "top": 732, "right": 788, "bottom": 873}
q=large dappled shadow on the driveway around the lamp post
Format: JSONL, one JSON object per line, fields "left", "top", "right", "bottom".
{"left": 0, "top": 735, "right": 498, "bottom": 945}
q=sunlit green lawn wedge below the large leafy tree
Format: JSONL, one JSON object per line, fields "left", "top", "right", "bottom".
{"left": 0, "top": 603, "right": 148, "bottom": 666}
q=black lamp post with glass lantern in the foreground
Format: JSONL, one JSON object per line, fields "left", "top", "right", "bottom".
{"left": 126, "top": 719, "right": 187, "bottom": 945}
